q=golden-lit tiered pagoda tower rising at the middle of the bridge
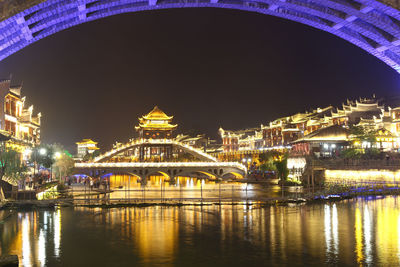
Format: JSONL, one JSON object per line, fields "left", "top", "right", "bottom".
{"left": 135, "top": 106, "right": 178, "bottom": 162}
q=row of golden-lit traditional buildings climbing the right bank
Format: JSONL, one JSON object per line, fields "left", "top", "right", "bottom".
{"left": 219, "top": 97, "right": 400, "bottom": 155}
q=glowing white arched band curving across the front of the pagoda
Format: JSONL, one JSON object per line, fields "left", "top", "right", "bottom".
{"left": 93, "top": 139, "right": 217, "bottom": 162}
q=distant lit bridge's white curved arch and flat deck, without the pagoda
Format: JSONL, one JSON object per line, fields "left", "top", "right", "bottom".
{"left": 75, "top": 139, "right": 247, "bottom": 184}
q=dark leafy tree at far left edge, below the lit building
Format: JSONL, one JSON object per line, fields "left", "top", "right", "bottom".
{"left": 0, "top": 147, "right": 27, "bottom": 200}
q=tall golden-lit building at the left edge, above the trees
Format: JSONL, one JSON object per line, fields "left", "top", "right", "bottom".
{"left": 0, "top": 79, "right": 41, "bottom": 152}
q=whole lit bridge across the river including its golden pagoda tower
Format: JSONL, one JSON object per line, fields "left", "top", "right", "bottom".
{"left": 75, "top": 107, "right": 247, "bottom": 181}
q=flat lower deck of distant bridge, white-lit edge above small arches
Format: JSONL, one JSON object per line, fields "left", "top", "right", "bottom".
{"left": 75, "top": 162, "right": 247, "bottom": 182}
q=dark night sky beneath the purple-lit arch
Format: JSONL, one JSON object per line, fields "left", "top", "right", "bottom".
{"left": 0, "top": 9, "right": 400, "bottom": 153}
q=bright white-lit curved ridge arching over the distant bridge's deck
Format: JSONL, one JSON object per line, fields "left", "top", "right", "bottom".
{"left": 93, "top": 139, "right": 218, "bottom": 162}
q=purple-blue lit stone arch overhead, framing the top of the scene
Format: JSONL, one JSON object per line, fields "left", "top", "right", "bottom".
{"left": 0, "top": 0, "right": 400, "bottom": 72}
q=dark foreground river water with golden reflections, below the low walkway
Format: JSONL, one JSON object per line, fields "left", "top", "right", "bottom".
{"left": 0, "top": 197, "right": 400, "bottom": 266}
